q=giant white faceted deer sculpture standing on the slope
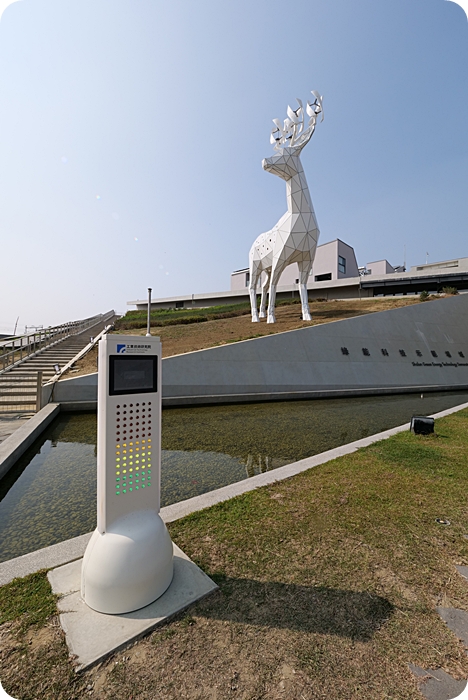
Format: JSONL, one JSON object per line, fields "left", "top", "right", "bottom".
{"left": 249, "top": 90, "right": 323, "bottom": 323}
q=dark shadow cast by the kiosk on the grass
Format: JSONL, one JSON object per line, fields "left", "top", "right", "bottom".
{"left": 200, "top": 576, "right": 394, "bottom": 642}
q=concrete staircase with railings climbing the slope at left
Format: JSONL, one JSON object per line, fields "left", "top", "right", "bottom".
{"left": 0, "top": 318, "right": 115, "bottom": 414}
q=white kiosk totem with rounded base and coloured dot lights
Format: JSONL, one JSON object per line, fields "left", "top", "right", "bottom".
{"left": 81, "top": 335, "right": 173, "bottom": 614}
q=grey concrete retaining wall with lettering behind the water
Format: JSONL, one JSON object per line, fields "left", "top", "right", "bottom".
{"left": 44, "top": 294, "right": 468, "bottom": 406}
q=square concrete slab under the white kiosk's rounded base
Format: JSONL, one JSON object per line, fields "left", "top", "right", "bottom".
{"left": 47, "top": 545, "right": 218, "bottom": 671}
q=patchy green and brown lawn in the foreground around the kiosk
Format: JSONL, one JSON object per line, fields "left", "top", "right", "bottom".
{"left": 0, "top": 410, "right": 468, "bottom": 700}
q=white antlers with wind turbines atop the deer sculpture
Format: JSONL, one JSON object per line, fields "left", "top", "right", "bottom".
{"left": 270, "top": 90, "right": 323, "bottom": 151}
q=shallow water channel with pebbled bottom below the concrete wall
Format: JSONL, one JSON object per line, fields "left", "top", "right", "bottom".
{"left": 0, "top": 392, "right": 468, "bottom": 561}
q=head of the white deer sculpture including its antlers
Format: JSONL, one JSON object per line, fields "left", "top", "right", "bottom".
{"left": 262, "top": 90, "right": 323, "bottom": 181}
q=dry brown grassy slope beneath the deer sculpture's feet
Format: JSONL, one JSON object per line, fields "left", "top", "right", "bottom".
{"left": 64, "top": 297, "right": 418, "bottom": 378}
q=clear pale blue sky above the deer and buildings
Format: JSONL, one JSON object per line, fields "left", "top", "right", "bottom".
{"left": 0, "top": 0, "right": 468, "bottom": 332}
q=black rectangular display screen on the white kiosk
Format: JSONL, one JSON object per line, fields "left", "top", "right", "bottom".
{"left": 109, "top": 355, "right": 158, "bottom": 396}
